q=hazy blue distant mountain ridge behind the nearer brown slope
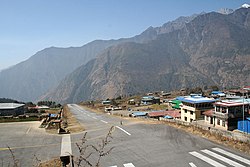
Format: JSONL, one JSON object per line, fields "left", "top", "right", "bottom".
{"left": 0, "top": 15, "right": 197, "bottom": 101}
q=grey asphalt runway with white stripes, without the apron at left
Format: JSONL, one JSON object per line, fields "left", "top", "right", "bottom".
{"left": 69, "top": 104, "right": 250, "bottom": 167}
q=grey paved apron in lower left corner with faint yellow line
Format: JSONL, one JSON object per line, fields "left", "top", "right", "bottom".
{"left": 0, "top": 121, "right": 62, "bottom": 167}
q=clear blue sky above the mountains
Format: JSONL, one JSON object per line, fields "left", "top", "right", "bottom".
{"left": 0, "top": 0, "right": 250, "bottom": 70}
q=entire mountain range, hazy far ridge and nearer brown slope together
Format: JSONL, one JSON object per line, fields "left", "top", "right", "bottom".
{"left": 0, "top": 8, "right": 250, "bottom": 103}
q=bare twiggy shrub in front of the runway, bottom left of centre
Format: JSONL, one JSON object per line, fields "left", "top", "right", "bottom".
{"left": 76, "top": 126, "right": 115, "bottom": 167}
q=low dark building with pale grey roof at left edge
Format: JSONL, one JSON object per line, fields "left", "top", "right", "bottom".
{"left": 0, "top": 103, "right": 25, "bottom": 116}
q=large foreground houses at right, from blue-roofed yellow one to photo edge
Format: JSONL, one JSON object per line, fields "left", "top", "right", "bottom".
{"left": 176, "top": 87, "right": 250, "bottom": 133}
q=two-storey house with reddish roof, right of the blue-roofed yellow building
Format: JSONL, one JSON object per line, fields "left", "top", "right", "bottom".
{"left": 204, "top": 99, "right": 250, "bottom": 130}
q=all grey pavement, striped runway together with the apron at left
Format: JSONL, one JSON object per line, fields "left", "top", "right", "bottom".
{"left": 0, "top": 104, "right": 250, "bottom": 167}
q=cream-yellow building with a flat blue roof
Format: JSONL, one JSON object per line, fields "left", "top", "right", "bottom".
{"left": 178, "top": 95, "right": 215, "bottom": 122}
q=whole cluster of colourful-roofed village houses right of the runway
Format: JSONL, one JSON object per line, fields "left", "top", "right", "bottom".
{"left": 118, "top": 86, "right": 250, "bottom": 133}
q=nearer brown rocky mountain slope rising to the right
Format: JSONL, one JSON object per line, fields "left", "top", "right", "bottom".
{"left": 46, "top": 9, "right": 250, "bottom": 102}
